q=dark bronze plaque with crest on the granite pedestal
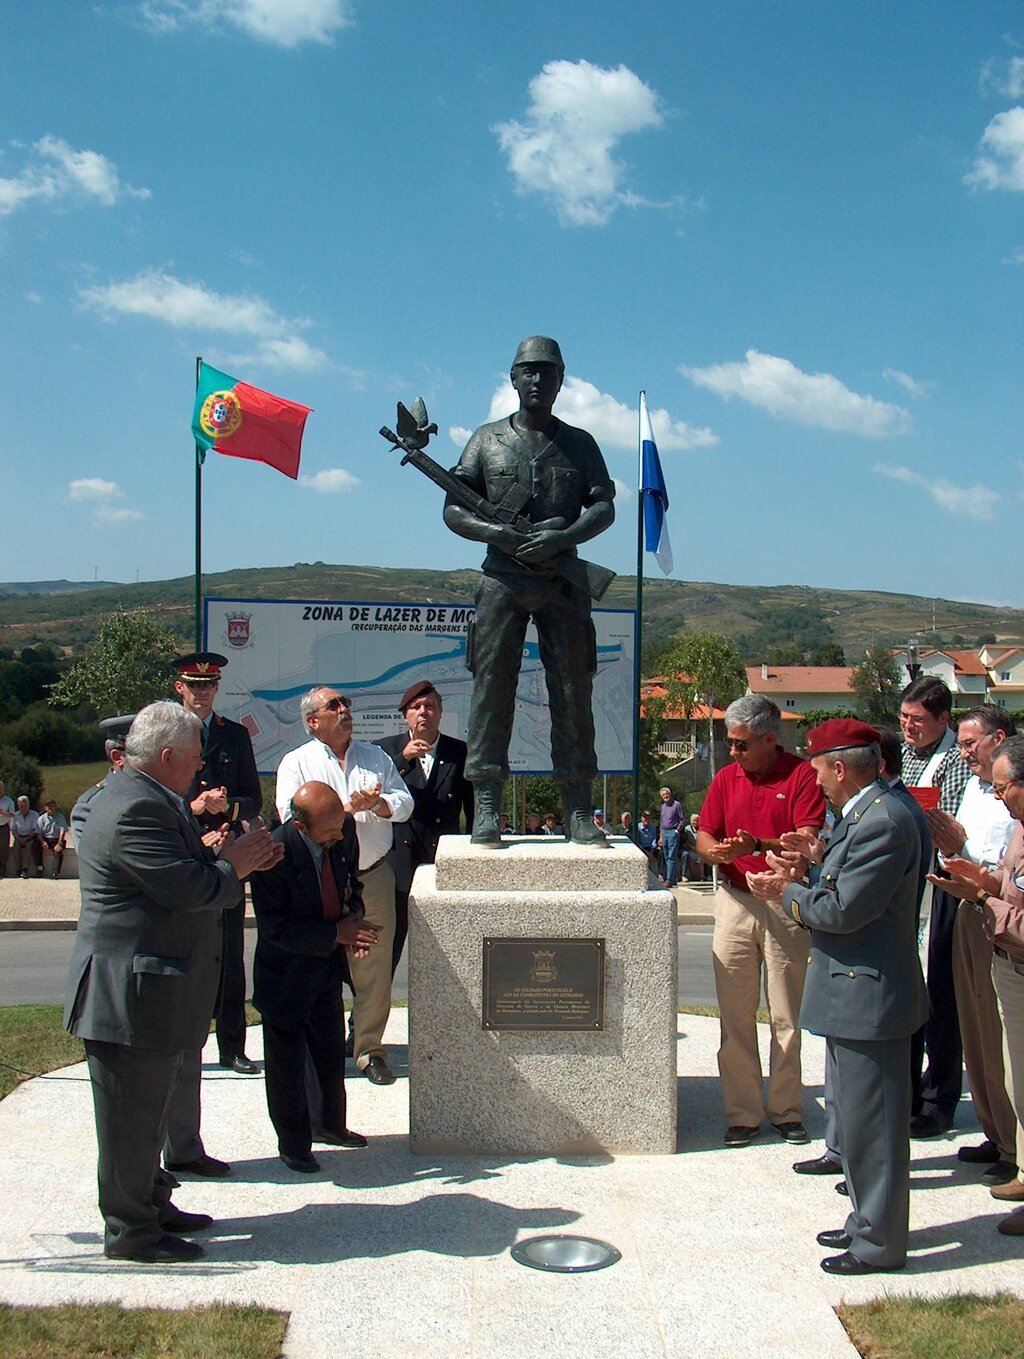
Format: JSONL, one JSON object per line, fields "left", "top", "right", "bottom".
{"left": 483, "top": 938, "right": 605, "bottom": 1033}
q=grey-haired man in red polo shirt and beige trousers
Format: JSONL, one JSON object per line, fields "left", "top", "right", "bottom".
{"left": 696, "top": 694, "right": 825, "bottom": 1147}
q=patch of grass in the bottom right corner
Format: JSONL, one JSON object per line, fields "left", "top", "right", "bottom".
{"left": 838, "top": 1292, "right": 1024, "bottom": 1359}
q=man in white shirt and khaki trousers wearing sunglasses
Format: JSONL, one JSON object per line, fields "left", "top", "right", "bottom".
{"left": 273, "top": 688, "right": 412, "bottom": 1086}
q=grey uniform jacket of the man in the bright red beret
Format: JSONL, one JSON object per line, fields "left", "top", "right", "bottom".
{"left": 782, "top": 783, "right": 927, "bottom": 1041}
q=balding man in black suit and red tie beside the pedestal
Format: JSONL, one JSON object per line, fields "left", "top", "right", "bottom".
{"left": 253, "top": 783, "right": 379, "bottom": 1174}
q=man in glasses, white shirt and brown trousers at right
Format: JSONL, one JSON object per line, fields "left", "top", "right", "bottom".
{"left": 925, "top": 704, "right": 1017, "bottom": 1186}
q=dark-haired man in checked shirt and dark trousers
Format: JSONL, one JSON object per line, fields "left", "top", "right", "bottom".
{"left": 899, "top": 675, "right": 971, "bottom": 1137}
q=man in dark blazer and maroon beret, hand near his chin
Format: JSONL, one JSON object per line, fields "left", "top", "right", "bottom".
{"left": 377, "top": 680, "right": 473, "bottom": 976}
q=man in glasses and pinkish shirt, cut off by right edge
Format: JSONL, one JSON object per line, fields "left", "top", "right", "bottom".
{"left": 933, "top": 735, "right": 1024, "bottom": 1237}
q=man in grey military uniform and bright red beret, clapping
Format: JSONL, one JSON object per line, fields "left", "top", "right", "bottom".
{"left": 747, "top": 718, "right": 927, "bottom": 1276}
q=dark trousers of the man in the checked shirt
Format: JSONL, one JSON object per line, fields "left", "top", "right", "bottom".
{"left": 911, "top": 887, "right": 964, "bottom": 1118}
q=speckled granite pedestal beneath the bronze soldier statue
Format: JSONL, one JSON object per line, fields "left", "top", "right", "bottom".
{"left": 409, "top": 836, "right": 677, "bottom": 1157}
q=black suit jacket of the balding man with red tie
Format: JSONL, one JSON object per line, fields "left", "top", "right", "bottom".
{"left": 250, "top": 815, "right": 364, "bottom": 1027}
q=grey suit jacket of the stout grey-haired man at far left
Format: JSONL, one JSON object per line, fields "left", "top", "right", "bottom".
{"left": 64, "top": 765, "right": 242, "bottom": 1051}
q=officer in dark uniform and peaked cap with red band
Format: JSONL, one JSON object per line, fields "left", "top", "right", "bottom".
{"left": 174, "top": 651, "right": 262, "bottom": 1076}
